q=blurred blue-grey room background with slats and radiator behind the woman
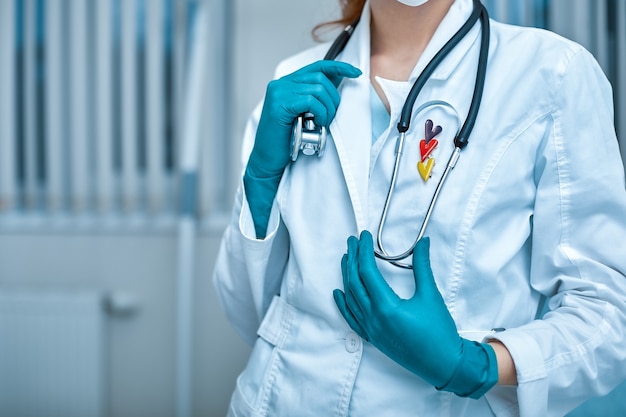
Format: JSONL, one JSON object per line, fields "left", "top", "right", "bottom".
{"left": 0, "top": 0, "right": 626, "bottom": 417}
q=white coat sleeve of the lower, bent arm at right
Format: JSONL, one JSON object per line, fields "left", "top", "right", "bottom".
{"left": 490, "top": 49, "right": 626, "bottom": 417}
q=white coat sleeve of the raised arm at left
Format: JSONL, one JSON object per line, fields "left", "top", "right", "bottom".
{"left": 213, "top": 100, "right": 289, "bottom": 344}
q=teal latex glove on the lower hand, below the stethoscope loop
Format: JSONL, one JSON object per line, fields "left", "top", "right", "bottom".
{"left": 333, "top": 231, "right": 498, "bottom": 398}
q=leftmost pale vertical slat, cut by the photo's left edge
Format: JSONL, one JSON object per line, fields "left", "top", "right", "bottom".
{"left": 0, "top": 0, "right": 17, "bottom": 212}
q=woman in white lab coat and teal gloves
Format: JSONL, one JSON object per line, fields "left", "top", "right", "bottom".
{"left": 214, "top": 0, "right": 626, "bottom": 416}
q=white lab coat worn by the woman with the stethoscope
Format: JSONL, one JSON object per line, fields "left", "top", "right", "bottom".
{"left": 214, "top": 0, "right": 626, "bottom": 417}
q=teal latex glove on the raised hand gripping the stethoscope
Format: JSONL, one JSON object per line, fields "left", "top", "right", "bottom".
{"left": 244, "top": 61, "right": 361, "bottom": 238}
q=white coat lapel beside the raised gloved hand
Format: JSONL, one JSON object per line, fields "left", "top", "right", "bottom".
{"left": 330, "top": 3, "right": 372, "bottom": 231}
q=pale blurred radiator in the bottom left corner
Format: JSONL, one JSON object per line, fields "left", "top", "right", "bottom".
{"left": 0, "top": 289, "right": 106, "bottom": 417}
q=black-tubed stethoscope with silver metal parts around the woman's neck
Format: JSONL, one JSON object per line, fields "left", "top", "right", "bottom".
{"left": 291, "top": 0, "right": 490, "bottom": 269}
